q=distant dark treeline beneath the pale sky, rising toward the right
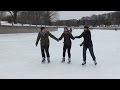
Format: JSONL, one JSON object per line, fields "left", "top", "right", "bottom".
{"left": 54, "top": 11, "right": 120, "bottom": 26}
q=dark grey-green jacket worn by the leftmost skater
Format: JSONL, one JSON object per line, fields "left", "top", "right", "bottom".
{"left": 36, "top": 31, "right": 58, "bottom": 46}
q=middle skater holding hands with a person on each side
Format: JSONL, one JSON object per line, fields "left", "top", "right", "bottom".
{"left": 59, "top": 27, "right": 75, "bottom": 63}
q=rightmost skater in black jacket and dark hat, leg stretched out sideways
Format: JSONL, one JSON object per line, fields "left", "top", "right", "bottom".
{"left": 75, "top": 26, "right": 97, "bottom": 65}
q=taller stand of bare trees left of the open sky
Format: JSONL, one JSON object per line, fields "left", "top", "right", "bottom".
{"left": 1, "top": 11, "right": 58, "bottom": 25}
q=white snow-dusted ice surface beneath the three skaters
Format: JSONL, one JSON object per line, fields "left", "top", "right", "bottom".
{"left": 0, "top": 28, "right": 120, "bottom": 79}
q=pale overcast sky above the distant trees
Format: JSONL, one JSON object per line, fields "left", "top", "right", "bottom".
{"left": 59, "top": 11, "right": 114, "bottom": 20}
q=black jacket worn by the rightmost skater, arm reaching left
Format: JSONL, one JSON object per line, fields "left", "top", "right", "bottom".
{"left": 75, "top": 30, "right": 93, "bottom": 47}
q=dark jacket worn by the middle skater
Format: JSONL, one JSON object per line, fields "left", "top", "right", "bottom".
{"left": 59, "top": 33, "right": 75, "bottom": 46}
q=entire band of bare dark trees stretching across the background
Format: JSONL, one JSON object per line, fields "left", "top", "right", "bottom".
{"left": 0, "top": 11, "right": 120, "bottom": 26}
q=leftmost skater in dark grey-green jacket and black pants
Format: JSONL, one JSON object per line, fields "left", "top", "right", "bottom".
{"left": 36, "top": 27, "right": 59, "bottom": 63}
